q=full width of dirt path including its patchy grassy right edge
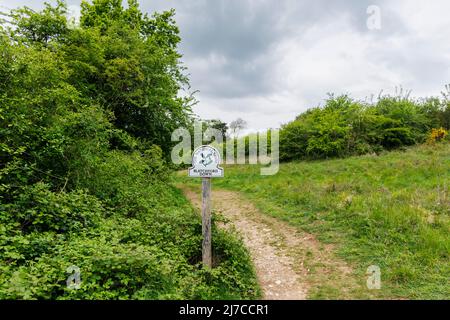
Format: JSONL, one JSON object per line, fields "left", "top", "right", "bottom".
{"left": 178, "top": 185, "right": 364, "bottom": 300}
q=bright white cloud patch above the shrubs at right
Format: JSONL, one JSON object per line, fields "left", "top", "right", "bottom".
{"left": 276, "top": 15, "right": 407, "bottom": 101}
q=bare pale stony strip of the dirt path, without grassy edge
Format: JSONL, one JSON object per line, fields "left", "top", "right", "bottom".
{"left": 183, "top": 188, "right": 307, "bottom": 300}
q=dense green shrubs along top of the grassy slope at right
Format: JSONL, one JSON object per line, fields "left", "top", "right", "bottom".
{"left": 280, "top": 95, "right": 450, "bottom": 160}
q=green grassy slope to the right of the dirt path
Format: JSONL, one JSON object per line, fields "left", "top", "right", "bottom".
{"left": 179, "top": 143, "right": 450, "bottom": 299}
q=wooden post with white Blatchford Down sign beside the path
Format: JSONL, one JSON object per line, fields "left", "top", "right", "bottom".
{"left": 189, "top": 146, "right": 223, "bottom": 268}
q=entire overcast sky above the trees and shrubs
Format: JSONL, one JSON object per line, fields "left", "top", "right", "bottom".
{"left": 0, "top": 0, "right": 450, "bottom": 130}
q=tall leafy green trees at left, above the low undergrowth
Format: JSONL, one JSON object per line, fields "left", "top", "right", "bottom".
{"left": 0, "top": 0, "right": 192, "bottom": 192}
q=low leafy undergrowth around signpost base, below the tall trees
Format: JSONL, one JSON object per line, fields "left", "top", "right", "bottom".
{"left": 0, "top": 187, "right": 258, "bottom": 299}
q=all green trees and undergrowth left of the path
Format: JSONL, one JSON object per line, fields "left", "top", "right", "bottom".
{"left": 0, "top": 0, "right": 259, "bottom": 299}
